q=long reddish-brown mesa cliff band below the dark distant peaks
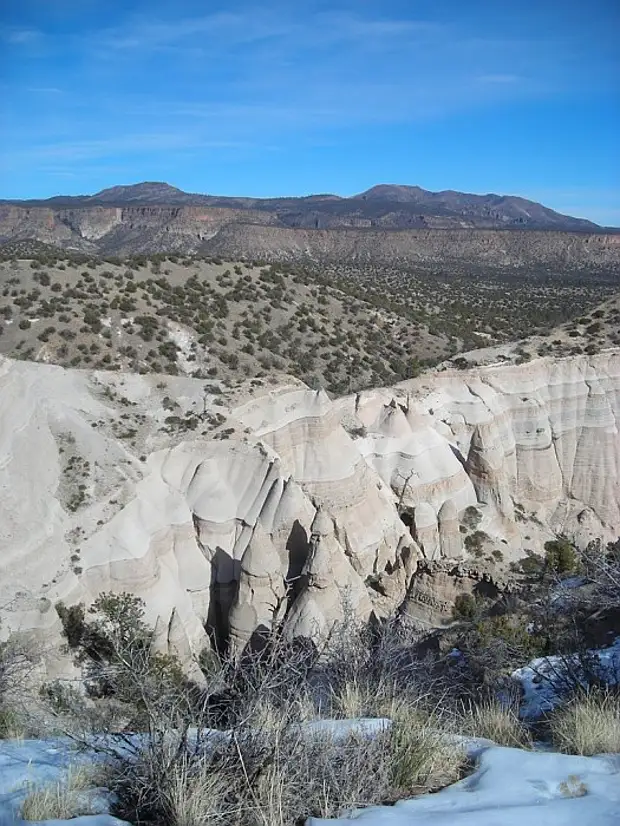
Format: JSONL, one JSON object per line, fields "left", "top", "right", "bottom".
{"left": 0, "top": 202, "right": 620, "bottom": 269}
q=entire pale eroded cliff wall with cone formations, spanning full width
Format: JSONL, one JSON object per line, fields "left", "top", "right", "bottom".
{"left": 0, "top": 350, "right": 620, "bottom": 671}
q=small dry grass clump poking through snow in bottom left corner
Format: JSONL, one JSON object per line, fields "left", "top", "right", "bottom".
{"left": 21, "top": 766, "right": 97, "bottom": 821}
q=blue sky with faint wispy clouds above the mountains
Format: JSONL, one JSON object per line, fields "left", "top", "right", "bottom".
{"left": 0, "top": 0, "right": 620, "bottom": 225}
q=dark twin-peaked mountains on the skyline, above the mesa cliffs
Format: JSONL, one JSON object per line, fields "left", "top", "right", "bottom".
{"left": 1, "top": 181, "right": 601, "bottom": 232}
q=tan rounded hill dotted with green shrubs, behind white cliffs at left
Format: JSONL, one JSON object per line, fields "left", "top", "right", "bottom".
{"left": 0, "top": 249, "right": 436, "bottom": 393}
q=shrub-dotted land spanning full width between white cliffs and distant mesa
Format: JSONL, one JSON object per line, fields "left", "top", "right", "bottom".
{"left": 0, "top": 244, "right": 620, "bottom": 394}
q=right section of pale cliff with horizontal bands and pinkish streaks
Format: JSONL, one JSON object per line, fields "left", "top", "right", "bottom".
{"left": 338, "top": 350, "right": 620, "bottom": 558}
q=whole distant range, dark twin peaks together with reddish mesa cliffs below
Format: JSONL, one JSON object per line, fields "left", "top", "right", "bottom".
{"left": 0, "top": 181, "right": 620, "bottom": 264}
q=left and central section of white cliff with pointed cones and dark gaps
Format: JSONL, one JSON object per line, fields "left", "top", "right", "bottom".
{"left": 0, "top": 359, "right": 418, "bottom": 660}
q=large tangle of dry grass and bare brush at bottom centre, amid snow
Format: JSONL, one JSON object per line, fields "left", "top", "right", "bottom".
{"left": 114, "top": 705, "right": 466, "bottom": 826}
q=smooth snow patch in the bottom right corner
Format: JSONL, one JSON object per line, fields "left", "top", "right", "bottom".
{"left": 308, "top": 746, "right": 620, "bottom": 826}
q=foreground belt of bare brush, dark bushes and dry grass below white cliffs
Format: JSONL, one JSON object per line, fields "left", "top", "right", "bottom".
{"left": 0, "top": 532, "right": 620, "bottom": 826}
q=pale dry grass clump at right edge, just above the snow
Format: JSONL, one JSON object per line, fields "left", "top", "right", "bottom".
{"left": 550, "top": 691, "right": 620, "bottom": 755}
